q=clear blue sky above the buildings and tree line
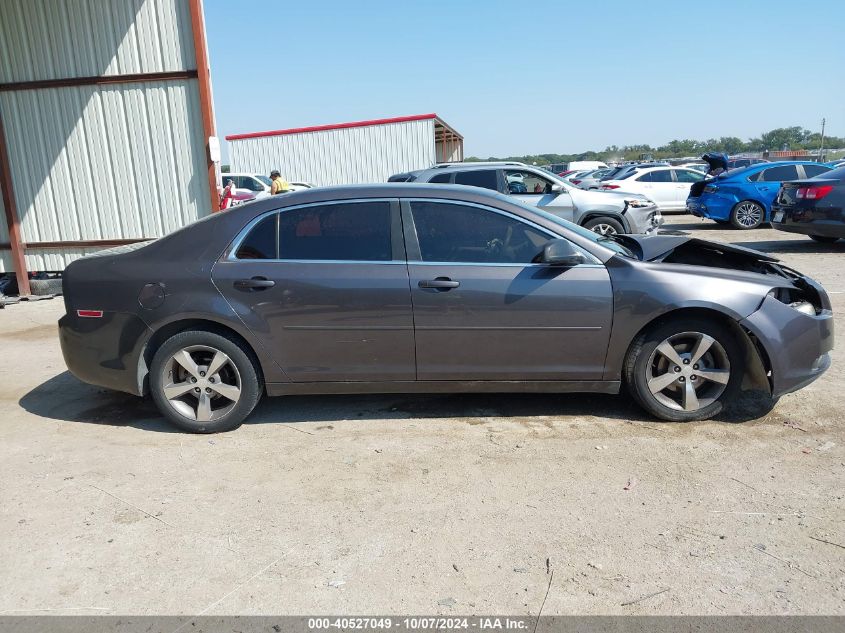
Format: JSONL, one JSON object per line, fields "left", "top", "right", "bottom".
{"left": 205, "top": 0, "right": 845, "bottom": 157}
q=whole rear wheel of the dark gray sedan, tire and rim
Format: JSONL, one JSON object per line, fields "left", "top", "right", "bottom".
{"left": 150, "top": 330, "right": 262, "bottom": 433}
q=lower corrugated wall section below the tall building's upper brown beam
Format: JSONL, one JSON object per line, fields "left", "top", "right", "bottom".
{"left": 0, "top": 80, "right": 210, "bottom": 270}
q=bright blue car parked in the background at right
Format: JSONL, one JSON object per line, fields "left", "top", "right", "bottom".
{"left": 687, "top": 161, "right": 830, "bottom": 229}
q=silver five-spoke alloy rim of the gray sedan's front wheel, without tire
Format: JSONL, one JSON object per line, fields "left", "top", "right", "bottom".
{"left": 646, "top": 332, "right": 731, "bottom": 412}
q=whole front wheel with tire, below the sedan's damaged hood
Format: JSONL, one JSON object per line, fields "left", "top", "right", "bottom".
{"left": 625, "top": 318, "right": 745, "bottom": 422}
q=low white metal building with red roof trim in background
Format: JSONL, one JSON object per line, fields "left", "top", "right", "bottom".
{"left": 226, "top": 114, "right": 464, "bottom": 186}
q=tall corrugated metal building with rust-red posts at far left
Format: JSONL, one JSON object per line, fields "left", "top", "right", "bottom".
{"left": 0, "top": 0, "right": 217, "bottom": 294}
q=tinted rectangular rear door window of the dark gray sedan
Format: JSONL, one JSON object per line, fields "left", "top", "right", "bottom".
{"left": 279, "top": 202, "right": 393, "bottom": 261}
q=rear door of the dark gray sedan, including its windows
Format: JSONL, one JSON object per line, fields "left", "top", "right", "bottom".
{"left": 212, "top": 200, "right": 416, "bottom": 382}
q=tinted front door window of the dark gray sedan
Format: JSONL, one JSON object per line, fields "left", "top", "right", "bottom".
{"left": 411, "top": 202, "right": 551, "bottom": 264}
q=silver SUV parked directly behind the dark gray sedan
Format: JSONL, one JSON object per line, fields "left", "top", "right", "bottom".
{"left": 389, "top": 162, "right": 663, "bottom": 234}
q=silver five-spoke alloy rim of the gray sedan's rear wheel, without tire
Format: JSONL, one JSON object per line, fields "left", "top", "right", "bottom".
{"left": 161, "top": 345, "right": 241, "bottom": 422}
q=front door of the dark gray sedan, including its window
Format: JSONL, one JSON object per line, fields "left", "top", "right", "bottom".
{"left": 402, "top": 200, "right": 613, "bottom": 380}
